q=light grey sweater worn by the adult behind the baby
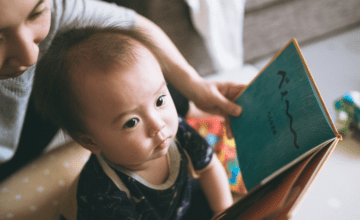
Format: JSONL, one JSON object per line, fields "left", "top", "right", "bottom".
{"left": 0, "top": 0, "right": 136, "bottom": 164}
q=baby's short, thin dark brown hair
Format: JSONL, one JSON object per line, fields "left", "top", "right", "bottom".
{"left": 33, "top": 26, "right": 167, "bottom": 141}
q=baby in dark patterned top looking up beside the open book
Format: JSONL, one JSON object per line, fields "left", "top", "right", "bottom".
{"left": 33, "top": 27, "right": 232, "bottom": 220}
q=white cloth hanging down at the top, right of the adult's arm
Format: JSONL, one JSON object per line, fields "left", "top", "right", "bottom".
{"left": 185, "top": 0, "right": 246, "bottom": 71}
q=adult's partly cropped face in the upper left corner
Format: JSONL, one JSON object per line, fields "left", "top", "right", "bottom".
{"left": 0, "top": 0, "right": 51, "bottom": 80}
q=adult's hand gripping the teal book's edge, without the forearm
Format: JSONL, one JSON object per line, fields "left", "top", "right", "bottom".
{"left": 189, "top": 79, "right": 246, "bottom": 138}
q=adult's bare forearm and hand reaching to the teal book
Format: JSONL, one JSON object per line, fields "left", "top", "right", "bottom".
{"left": 137, "top": 15, "right": 245, "bottom": 138}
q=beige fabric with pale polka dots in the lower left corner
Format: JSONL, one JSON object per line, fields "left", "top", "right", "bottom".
{"left": 0, "top": 143, "right": 90, "bottom": 220}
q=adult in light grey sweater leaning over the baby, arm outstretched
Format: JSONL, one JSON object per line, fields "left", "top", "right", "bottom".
{"left": 0, "top": 0, "right": 242, "bottom": 217}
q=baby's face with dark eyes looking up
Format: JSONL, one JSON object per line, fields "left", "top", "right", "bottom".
{"left": 74, "top": 45, "right": 178, "bottom": 170}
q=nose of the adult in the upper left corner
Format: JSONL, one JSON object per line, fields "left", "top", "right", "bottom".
{"left": 8, "top": 30, "right": 39, "bottom": 67}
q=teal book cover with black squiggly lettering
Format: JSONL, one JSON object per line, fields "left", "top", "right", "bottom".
{"left": 230, "top": 39, "right": 337, "bottom": 191}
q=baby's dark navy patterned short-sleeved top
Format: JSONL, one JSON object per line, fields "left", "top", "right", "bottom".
{"left": 77, "top": 117, "right": 213, "bottom": 220}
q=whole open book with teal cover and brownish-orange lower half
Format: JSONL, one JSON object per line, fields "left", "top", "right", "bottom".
{"left": 222, "top": 39, "right": 341, "bottom": 219}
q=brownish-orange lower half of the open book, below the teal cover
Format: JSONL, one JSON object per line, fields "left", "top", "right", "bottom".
{"left": 219, "top": 138, "right": 339, "bottom": 220}
